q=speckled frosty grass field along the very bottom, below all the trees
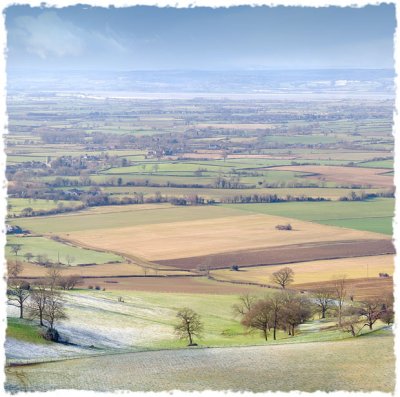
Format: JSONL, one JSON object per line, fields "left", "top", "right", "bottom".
{"left": 5, "top": 332, "right": 395, "bottom": 393}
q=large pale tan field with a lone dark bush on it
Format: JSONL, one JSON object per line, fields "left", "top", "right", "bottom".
{"left": 65, "top": 214, "right": 388, "bottom": 261}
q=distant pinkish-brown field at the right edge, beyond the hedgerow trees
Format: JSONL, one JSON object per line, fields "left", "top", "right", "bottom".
{"left": 273, "top": 165, "right": 393, "bottom": 187}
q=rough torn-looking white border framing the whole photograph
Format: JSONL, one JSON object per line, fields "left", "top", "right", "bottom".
{"left": 0, "top": 0, "right": 400, "bottom": 397}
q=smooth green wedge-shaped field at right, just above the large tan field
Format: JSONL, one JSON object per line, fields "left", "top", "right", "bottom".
{"left": 224, "top": 198, "right": 395, "bottom": 235}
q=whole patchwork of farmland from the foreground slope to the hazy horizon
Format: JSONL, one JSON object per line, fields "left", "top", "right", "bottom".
{"left": 5, "top": 67, "right": 395, "bottom": 392}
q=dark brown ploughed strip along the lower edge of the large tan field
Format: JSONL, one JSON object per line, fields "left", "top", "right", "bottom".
{"left": 158, "top": 240, "right": 395, "bottom": 270}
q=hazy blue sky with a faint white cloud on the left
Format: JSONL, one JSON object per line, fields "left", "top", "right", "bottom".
{"left": 5, "top": 5, "right": 396, "bottom": 70}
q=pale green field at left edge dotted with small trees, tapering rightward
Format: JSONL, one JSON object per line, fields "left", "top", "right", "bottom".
{"left": 5, "top": 236, "right": 124, "bottom": 265}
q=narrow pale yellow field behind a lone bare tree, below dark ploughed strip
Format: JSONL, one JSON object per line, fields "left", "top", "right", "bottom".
{"left": 212, "top": 255, "right": 394, "bottom": 285}
